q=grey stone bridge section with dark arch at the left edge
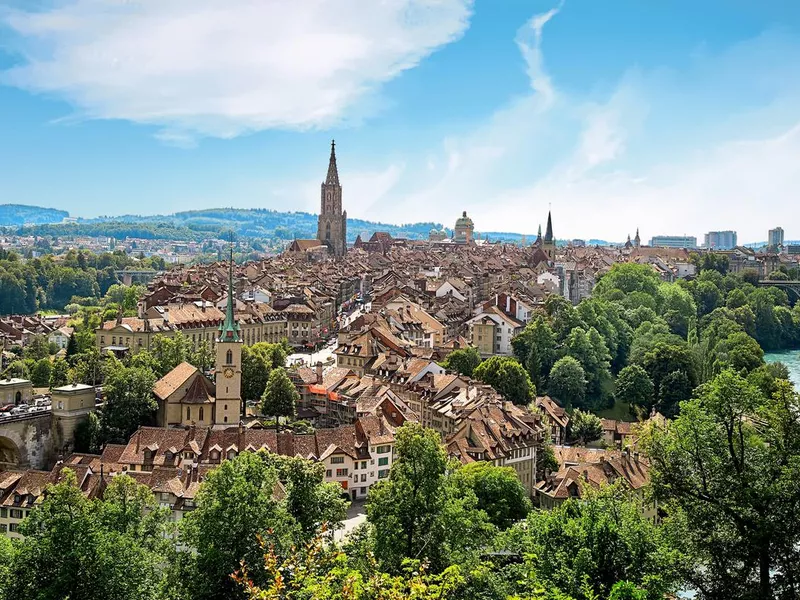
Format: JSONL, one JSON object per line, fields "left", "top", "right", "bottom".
{"left": 0, "top": 410, "right": 64, "bottom": 470}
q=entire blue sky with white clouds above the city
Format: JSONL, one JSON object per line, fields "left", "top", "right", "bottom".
{"left": 0, "top": 0, "right": 800, "bottom": 243}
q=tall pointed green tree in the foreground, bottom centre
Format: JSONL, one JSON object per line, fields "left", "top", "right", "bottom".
{"left": 367, "top": 422, "right": 491, "bottom": 572}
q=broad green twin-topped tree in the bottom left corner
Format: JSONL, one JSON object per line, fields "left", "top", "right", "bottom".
{"left": 7, "top": 469, "right": 166, "bottom": 600}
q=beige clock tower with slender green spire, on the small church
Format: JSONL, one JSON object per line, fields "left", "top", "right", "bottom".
{"left": 214, "top": 248, "right": 242, "bottom": 427}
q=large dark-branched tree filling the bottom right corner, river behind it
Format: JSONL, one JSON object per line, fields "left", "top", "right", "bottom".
{"left": 643, "top": 370, "right": 800, "bottom": 598}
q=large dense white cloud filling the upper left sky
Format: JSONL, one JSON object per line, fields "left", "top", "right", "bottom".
{"left": 0, "top": 0, "right": 472, "bottom": 137}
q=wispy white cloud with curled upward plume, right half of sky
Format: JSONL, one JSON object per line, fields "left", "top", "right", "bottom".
{"left": 364, "top": 7, "right": 800, "bottom": 242}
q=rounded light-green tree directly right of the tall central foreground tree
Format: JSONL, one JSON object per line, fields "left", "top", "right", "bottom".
{"left": 453, "top": 462, "right": 531, "bottom": 529}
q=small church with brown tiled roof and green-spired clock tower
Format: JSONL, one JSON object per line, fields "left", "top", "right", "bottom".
{"left": 153, "top": 250, "right": 242, "bottom": 427}
